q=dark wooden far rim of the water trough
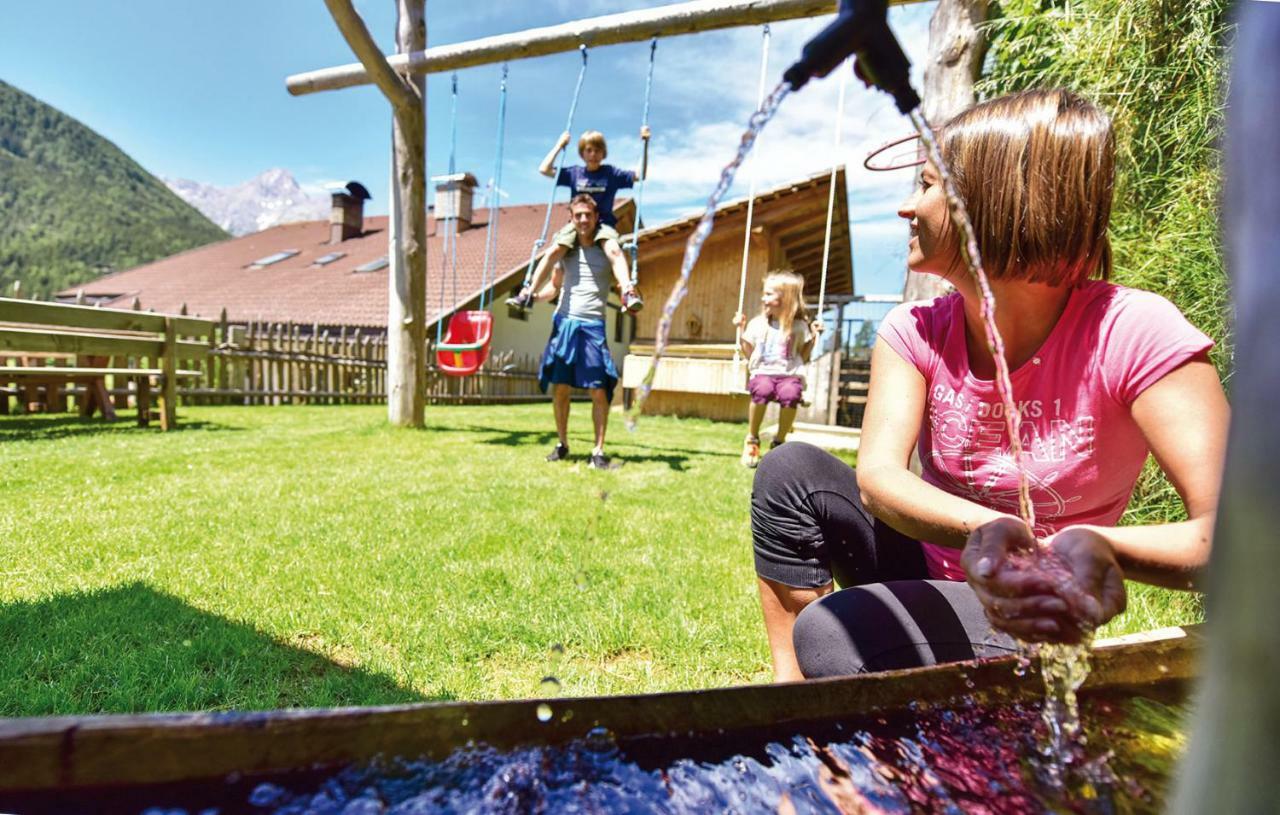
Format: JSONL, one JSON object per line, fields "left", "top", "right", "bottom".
{"left": 0, "top": 628, "right": 1199, "bottom": 812}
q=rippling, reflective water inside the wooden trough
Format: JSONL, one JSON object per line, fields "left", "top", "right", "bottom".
{"left": 241, "top": 693, "right": 1185, "bottom": 815}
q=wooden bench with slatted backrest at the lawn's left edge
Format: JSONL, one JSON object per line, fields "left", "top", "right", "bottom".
{"left": 0, "top": 297, "right": 214, "bottom": 430}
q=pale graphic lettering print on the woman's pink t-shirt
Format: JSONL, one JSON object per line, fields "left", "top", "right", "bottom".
{"left": 928, "top": 384, "right": 1094, "bottom": 536}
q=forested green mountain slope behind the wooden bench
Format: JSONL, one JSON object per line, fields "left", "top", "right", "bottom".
{"left": 0, "top": 82, "right": 228, "bottom": 297}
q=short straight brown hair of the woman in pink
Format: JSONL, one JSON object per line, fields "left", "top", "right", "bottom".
{"left": 942, "top": 88, "right": 1115, "bottom": 285}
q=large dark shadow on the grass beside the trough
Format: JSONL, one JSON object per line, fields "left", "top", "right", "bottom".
{"left": 0, "top": 583, "right": 430, "bottom": 716}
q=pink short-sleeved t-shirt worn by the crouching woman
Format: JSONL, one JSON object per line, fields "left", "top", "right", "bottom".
{"left": 879, "top": 280, "right": 1213, "bottom": 580}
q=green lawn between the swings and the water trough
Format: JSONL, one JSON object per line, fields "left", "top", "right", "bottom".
{"left": 0, "top": 404, "right": 1199, "bottom": 715}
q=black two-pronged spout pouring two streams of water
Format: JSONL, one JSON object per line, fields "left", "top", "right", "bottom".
{"left": 782, "top": 0, "right": 920, "bottom": 114}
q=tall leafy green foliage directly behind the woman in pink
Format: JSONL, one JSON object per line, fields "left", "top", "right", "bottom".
{"left": 979, "top": 0, "right": 1230, "bottom": 523}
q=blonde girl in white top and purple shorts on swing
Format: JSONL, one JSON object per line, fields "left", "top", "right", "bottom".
{"left": 733, "top": 271, "right": 824, "bottom": 467}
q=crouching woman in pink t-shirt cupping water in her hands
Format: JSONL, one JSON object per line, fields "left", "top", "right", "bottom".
{"left": 751, "top": 91, "right": 1228, "bottom": 681}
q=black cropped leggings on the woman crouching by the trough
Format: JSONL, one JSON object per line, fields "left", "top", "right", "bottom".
{"left": 751, "top": 441, "right": 1016, "bottom": 678}
